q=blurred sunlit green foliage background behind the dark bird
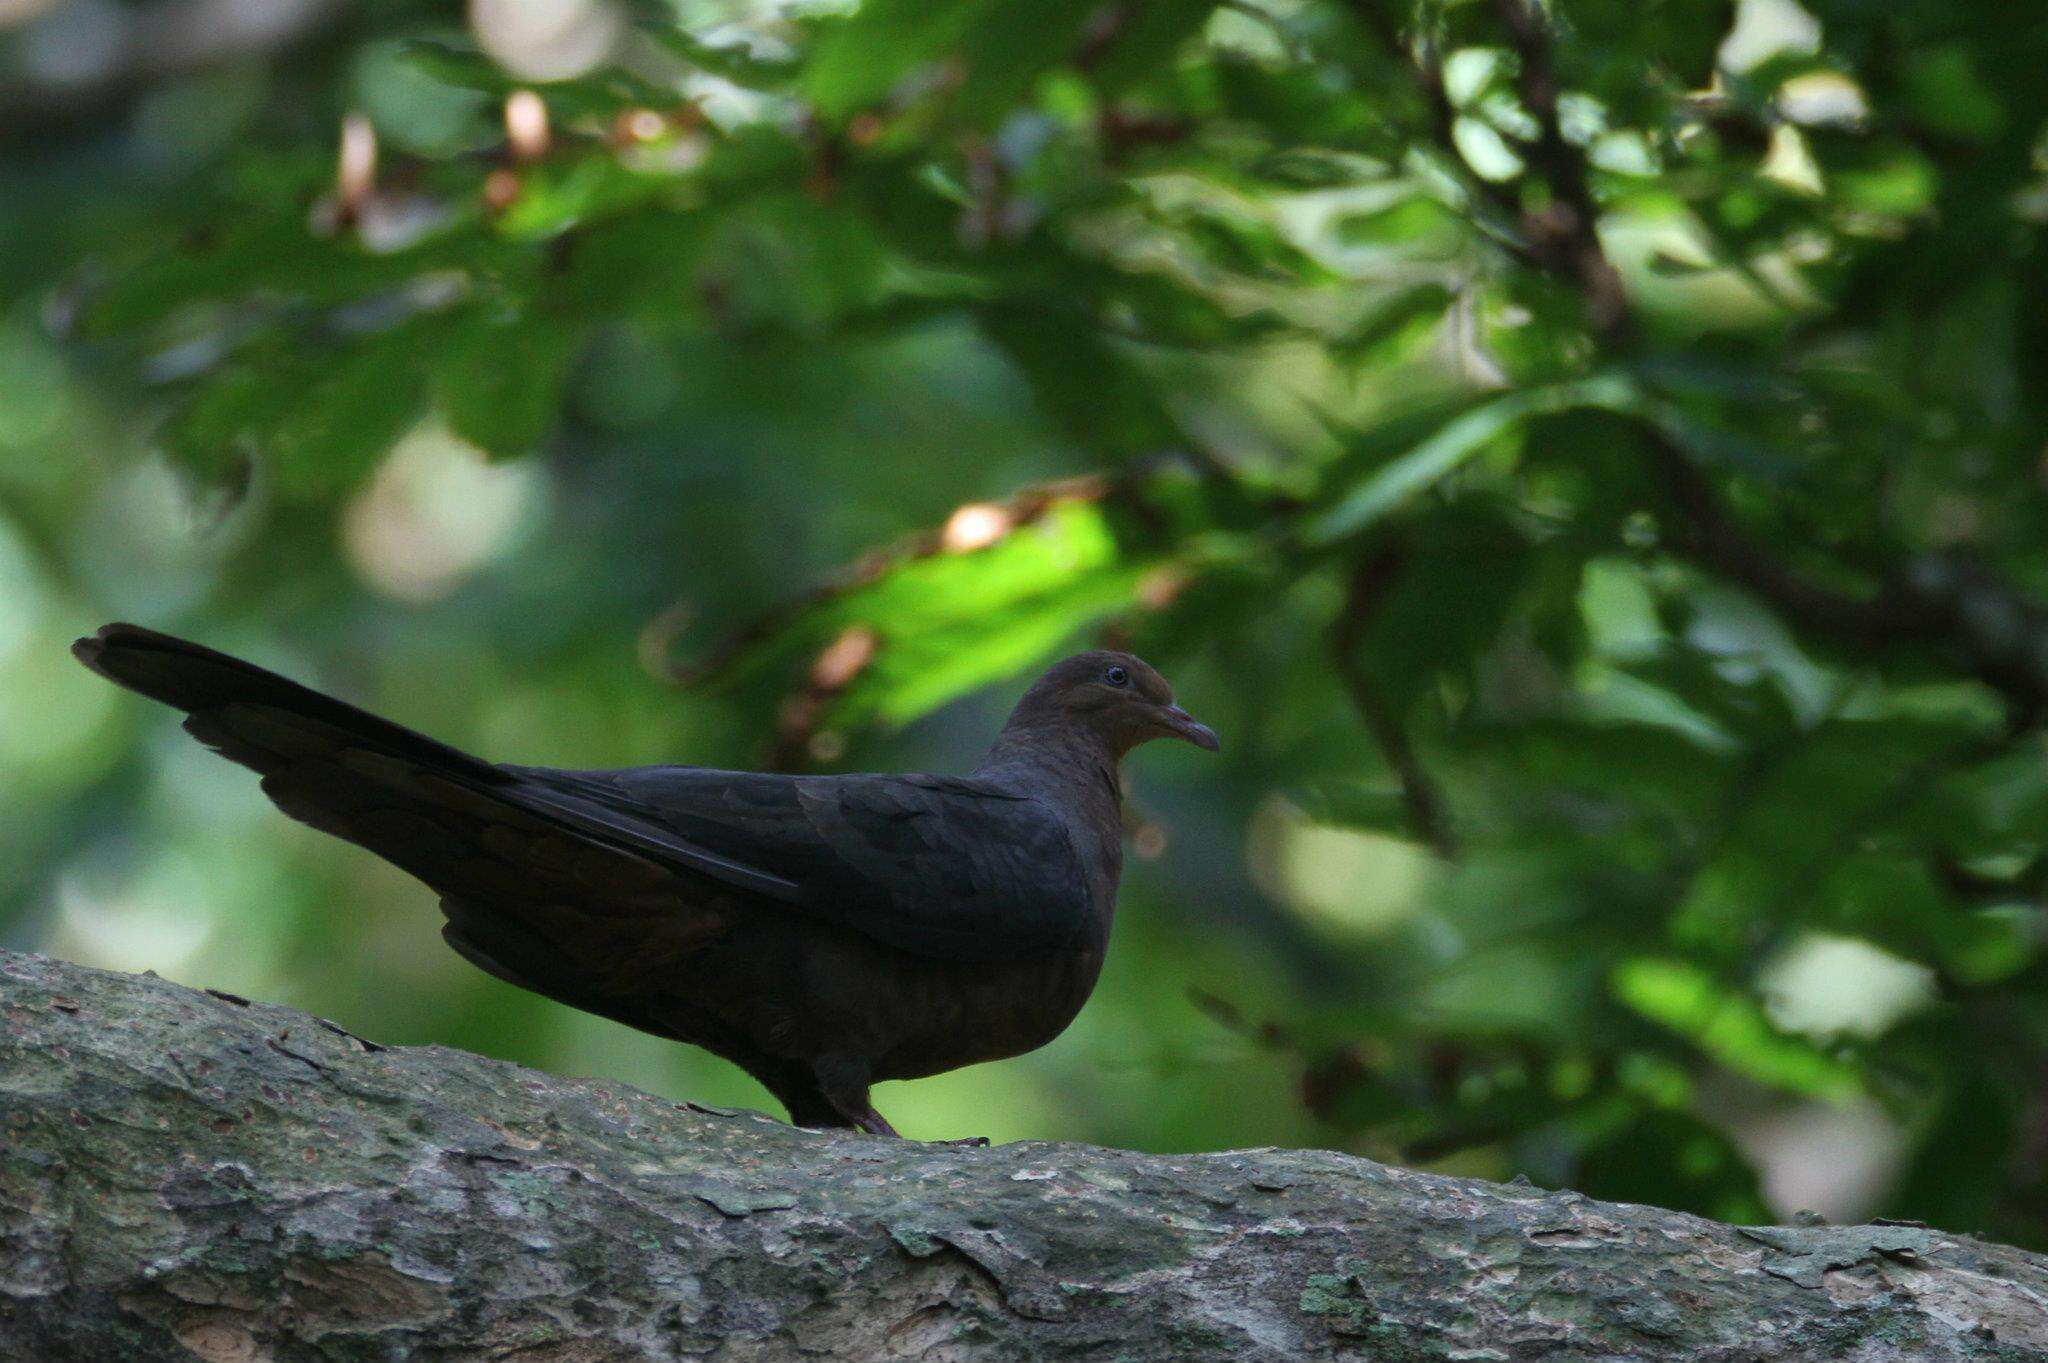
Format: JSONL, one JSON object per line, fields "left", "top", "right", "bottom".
{"left": 0, "top": 0, "right": 2048, "bottom": 1246}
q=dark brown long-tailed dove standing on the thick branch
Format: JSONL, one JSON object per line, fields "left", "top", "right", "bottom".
{"left": 72, "top": 624, "right": 1219, "bottom": 1136}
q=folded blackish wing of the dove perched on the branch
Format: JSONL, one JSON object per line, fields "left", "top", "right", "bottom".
{"left": 508, "top": 767, "right": 1102, "bottom": 960}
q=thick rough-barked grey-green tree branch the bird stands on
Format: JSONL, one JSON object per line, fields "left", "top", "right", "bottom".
{"left": 0, "top": 954, "right": 2048, "bottom": 1363}
